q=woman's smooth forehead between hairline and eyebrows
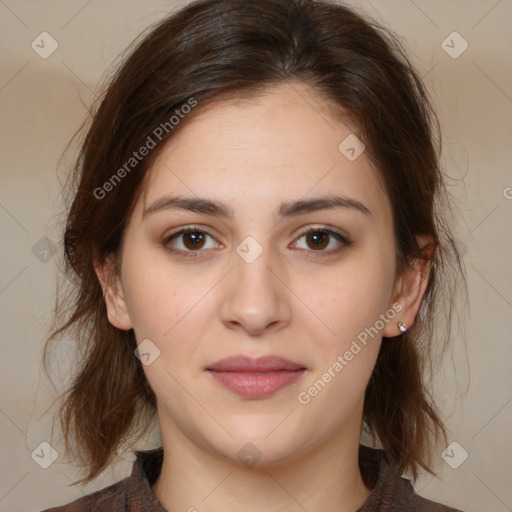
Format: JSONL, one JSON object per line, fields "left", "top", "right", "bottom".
{"left": 138, "top": 83, "right": 389, "bottom": 222}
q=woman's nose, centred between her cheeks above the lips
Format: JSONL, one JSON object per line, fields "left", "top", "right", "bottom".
{"left": 221, "top": 243, "right": 292, "bottom": 336}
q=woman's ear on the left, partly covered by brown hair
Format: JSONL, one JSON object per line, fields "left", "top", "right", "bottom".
{"left": 94, "top": 257, "right": 133, "bottom": 330}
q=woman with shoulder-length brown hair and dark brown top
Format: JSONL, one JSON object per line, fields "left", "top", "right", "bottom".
{"left": 42, "top": 0, "right": 466, "bottom": 512}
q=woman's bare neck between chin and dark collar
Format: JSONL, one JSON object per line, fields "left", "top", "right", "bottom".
{"left": 153, "top": 412, "right": 370, "bottom": 512}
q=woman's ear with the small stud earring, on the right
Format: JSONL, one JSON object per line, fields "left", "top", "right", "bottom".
{"left": 382, "top": 235, "right": 436, "bottom": 338}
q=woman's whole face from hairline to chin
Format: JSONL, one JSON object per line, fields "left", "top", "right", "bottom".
{"left": 98, "top": 83, "right": 422, "bottom": 465}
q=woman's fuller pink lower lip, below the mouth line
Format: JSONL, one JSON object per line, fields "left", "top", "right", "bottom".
{"left": 209, "top": 369, "right": 306, "bottom": 398}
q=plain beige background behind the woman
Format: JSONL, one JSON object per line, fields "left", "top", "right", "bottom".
{"left": 0, "top": 0, "right": 512, "bottom": 512}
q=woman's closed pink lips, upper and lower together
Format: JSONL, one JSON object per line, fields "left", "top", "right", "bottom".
{"left": 206, "top": 356, "right": 306, "bottom": 398}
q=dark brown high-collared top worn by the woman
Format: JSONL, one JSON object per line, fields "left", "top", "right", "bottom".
{"left": 43, "top": 445, "right": 462, "bottom": 512}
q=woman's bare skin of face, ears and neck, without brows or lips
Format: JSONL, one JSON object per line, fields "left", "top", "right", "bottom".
{"left": 96, "top": 82, "right": 429, "bottom": 512}
